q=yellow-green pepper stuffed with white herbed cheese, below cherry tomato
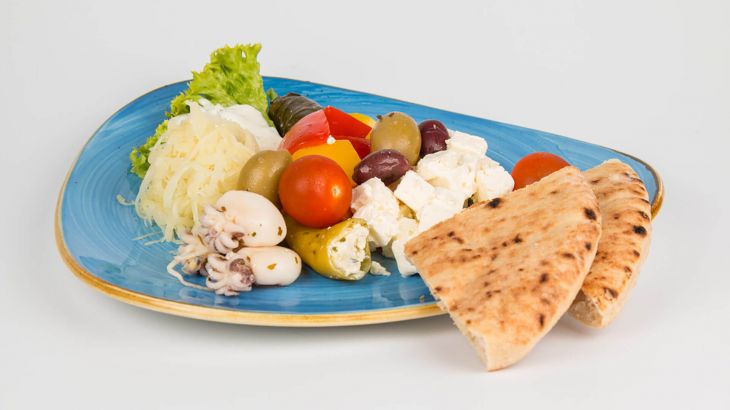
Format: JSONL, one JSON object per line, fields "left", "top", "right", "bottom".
{"left": 285, "top": 216, "right": 370, "bottom": 280}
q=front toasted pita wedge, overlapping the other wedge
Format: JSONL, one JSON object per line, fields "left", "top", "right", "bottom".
{"left": 406, "top": 167, "right": 601, "bottom": 370}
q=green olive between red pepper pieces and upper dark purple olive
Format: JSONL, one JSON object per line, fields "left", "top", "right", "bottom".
{"left": 370, "top": 112, "right": 421, "bottom": 165}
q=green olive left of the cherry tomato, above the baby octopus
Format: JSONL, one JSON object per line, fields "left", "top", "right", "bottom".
{"left": 238, "top": 150, "right": 291, "bottom": 206}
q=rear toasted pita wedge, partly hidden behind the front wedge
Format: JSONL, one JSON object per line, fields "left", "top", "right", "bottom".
{"left": 570, "top": 160, "right": 651, "bottom": 327}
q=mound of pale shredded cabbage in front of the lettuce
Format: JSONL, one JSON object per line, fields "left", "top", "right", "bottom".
{"left": 135, "top": 102, "right": 259, "bottom": 241}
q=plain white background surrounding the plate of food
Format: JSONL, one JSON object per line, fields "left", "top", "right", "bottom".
{"left": 0, "top": 0, "right": 730, "bottom": 409}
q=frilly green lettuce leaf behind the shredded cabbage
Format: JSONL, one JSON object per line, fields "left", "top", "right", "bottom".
{"left": 129, "top": 44, "right": 272, "bottom": 178}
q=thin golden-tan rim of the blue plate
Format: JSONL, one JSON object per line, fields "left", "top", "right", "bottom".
{"left": 54, "top": 76, "right": 664, "bottom": 327}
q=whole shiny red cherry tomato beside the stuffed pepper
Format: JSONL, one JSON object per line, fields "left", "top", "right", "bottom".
{"left": 279, "top": 155, "right": 352, "bottom": 228}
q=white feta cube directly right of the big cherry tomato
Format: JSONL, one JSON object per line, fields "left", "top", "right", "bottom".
{"left": 350, "top": 178, "right": 400, "bottom": 247}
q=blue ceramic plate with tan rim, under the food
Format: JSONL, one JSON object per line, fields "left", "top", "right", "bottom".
{"left": 56, "top": 77, "right": 662, "bottom": 326}
